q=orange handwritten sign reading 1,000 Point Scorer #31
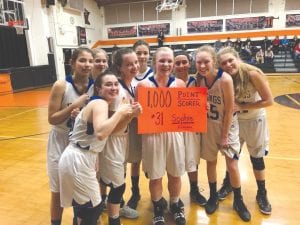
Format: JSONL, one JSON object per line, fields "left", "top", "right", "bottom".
{"left": 138, "top": 87, "right": 207, "bottom": 134}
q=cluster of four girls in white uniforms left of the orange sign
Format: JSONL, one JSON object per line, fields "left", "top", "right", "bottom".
{"left": 47, "top": 42, "right": 148, "bottom": 225}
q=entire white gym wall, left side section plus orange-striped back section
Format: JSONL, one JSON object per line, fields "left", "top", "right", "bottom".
{"left": 24, "top": 0, "right": 300, "bottom": 78}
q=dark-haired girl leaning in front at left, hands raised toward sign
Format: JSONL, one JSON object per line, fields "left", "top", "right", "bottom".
{"left": 59, "top": 71, "right": 132, "bottom": 225}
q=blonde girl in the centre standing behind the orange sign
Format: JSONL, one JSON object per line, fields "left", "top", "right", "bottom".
{"left": 138, "top": 47, "right": 186, "bottom": 225}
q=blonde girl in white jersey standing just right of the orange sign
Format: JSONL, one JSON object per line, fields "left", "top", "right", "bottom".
{"left": 196, "top": 45, "right": 251, "bottom": 221}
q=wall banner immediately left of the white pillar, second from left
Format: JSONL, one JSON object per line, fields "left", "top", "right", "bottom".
{"left": 138, "top": 23, "right": 170, "bottom": 36}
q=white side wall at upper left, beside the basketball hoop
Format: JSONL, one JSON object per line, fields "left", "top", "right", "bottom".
{"left": 24, "top": 0, "right": 103, "bottom": 78}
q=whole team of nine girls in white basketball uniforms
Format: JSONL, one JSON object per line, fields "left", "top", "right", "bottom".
{"left": 47, "top": 40, "right": 273, "bottom": 225}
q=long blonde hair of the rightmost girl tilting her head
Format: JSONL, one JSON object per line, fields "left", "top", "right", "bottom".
{"left": 217, "top": 47, "right": 264, "bottom": 98}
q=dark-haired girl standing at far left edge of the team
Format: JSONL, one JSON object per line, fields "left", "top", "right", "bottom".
{"left": 47, "top": 47, "right": 94, "bottom": 225}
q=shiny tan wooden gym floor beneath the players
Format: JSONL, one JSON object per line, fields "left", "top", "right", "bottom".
{"left": 0, "top": 75, "right": 300, "bottom": 225}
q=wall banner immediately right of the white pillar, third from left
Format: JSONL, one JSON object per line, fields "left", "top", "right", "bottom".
{"left": 187, "top": 19, "right": 223, "bottom": 33}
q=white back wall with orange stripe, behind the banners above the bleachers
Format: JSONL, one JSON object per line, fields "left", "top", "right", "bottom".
{"left": 93, "top": 0, "right": 300, "bottom": 48}
